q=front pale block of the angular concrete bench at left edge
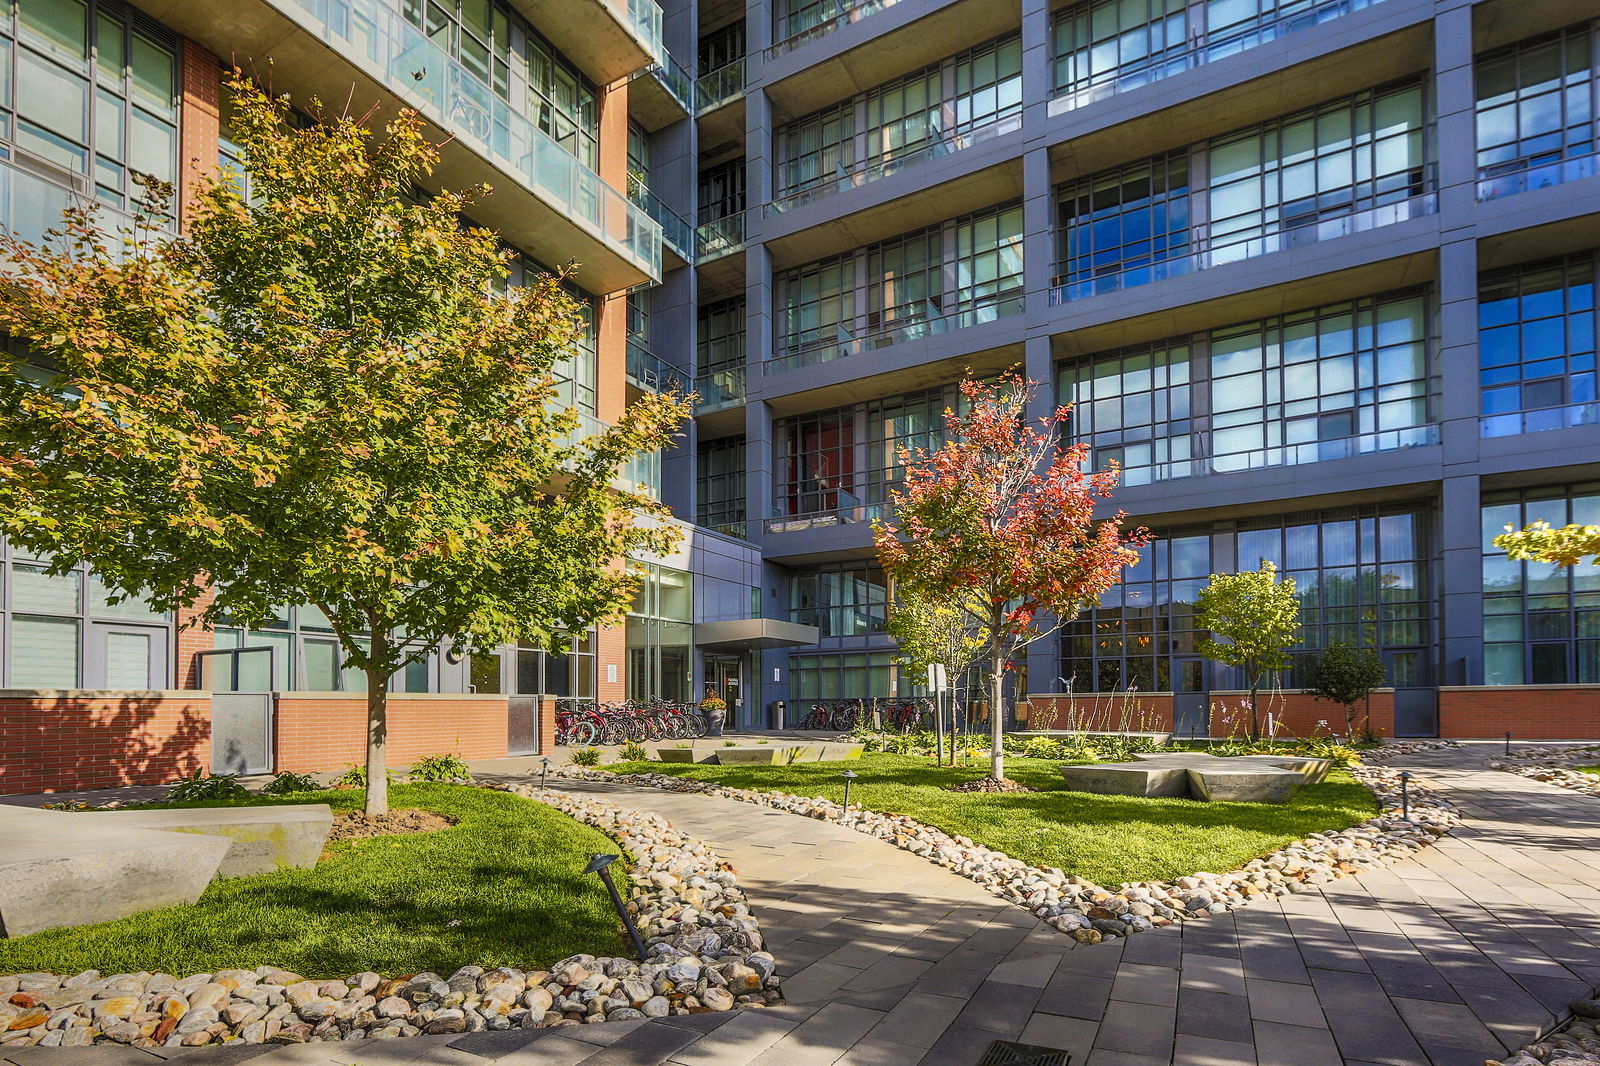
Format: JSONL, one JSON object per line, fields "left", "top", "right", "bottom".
{"left": 0, "top": 805, "right": 232, "bottom": 936}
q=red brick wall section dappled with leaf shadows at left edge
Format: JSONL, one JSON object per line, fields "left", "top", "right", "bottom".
{"left": 0, "top": 690, "right": 211, "bottom": 795}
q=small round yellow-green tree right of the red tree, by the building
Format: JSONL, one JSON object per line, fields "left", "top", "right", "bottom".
{"left": 1195, "top": 562, "right": 1299, "bottom": 739}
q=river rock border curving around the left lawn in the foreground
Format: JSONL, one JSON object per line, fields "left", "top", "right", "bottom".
{"left": 0, "top": 784, "right": 779, "bottom": 1052}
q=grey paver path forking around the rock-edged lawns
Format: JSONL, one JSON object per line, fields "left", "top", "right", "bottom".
{"left": 0, "top": 749, "right": 1600, "bottom": 1066}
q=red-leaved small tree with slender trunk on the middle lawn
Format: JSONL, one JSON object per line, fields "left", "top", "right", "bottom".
{"left": 874, "top": 375, "right": 1149, "bottom": 781}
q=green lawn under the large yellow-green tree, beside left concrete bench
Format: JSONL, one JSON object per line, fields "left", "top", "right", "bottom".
{"left": 0, "top": 784, "right": 626, "bottom": 978}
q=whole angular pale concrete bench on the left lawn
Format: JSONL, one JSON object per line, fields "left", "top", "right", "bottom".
{"left": 0, "top": 804, "right": 333, "bottom": 936}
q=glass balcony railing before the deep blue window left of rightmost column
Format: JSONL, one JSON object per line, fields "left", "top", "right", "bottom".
{"left": 1050, "top": 182, "right": 1438, "bottom": 306}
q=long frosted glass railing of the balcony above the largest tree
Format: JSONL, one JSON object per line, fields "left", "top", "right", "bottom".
{"left": 274, "top": 0, "right": 661, "bottom": 279}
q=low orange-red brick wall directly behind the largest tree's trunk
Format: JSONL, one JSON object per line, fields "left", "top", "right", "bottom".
{"left": 274, "top": 691, "right": 506, "bottom": 773}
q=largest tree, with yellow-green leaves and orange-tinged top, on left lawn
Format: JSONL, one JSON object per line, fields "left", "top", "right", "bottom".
{"left": 0, "top": 74, "right": 686, "bottom": 813}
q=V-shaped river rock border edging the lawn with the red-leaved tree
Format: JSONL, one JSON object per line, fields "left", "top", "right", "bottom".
{"left": 554, "top": 765, "right": 1461, "bottom": 944}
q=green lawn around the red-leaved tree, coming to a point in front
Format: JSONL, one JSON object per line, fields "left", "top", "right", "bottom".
{"left": 605, "top": 755, "right": 1378, "bottom": 885}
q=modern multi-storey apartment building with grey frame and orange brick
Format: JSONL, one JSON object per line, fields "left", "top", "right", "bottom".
{"left": 0, "top": 0, "right": 1600, "bottom": 791}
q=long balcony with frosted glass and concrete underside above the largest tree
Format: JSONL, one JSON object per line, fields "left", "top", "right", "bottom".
{"left": 141, "top": 0, "right": 661, "bottom": 293}
